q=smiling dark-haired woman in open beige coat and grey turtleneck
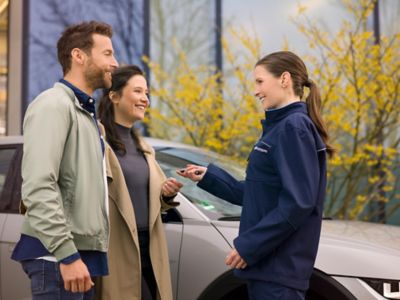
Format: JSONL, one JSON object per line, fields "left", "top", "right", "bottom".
{"left": 95, "top": 66, "right": 182, "bottom": 300}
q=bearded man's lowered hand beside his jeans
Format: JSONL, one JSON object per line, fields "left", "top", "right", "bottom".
{"left": 60, "top": 259, "right": 94, "bottom": 293}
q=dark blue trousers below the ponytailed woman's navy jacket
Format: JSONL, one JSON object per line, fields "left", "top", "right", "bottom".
{"left": 247, "top": 280, "right": 305, "bottom": 300}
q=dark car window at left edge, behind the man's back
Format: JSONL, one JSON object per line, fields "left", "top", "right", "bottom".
{"left": 0, "top": 145, "right": 22, "bottom": 213}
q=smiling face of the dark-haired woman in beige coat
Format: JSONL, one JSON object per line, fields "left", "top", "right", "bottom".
{"left": 112, "top": 75, "right": 149, "bottom": 127}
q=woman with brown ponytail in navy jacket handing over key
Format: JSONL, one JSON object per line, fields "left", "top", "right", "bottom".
{"left": 178, "top": 51, "right": 334, "bottom": 300}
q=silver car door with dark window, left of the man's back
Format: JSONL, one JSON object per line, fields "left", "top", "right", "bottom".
{"left": 0, "top": 143, "right": 31, "bottom": 300}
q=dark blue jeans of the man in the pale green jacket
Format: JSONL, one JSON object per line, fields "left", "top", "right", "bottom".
{"left": 21, "top": 259, "right": 94, "bottom": 300}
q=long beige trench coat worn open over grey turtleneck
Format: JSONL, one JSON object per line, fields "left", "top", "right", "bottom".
{"left": 95, "top": 135, "right": 178, "bottom": 300}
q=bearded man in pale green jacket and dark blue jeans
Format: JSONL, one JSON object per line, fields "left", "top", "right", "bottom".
{"left": 12, "top": 21, "right": 118, "bottom": 300}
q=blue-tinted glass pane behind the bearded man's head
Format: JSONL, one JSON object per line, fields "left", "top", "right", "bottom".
{"left": 24, "top": 0, "right": 144, "bottom": 103}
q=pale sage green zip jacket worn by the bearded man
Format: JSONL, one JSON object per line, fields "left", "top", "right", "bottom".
{"left": 22, "top": 83, "right": 109, "bottom": 261}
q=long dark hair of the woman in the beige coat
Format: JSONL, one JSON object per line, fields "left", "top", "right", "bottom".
{"left": 99, "top": 65, "right": 144, "bottom": 155}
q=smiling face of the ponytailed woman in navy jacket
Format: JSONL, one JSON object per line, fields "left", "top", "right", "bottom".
{"left": 253, "top": 65, "right": 285, "bottom": 110}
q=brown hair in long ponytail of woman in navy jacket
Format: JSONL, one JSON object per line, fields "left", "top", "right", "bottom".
{"left": 256, "top": 51, "right": 335, "bottom": 157}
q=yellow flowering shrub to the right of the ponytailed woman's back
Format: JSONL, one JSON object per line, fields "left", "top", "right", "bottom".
{"left": 294, "top": 0, "right": 400, "bottom": 223}
